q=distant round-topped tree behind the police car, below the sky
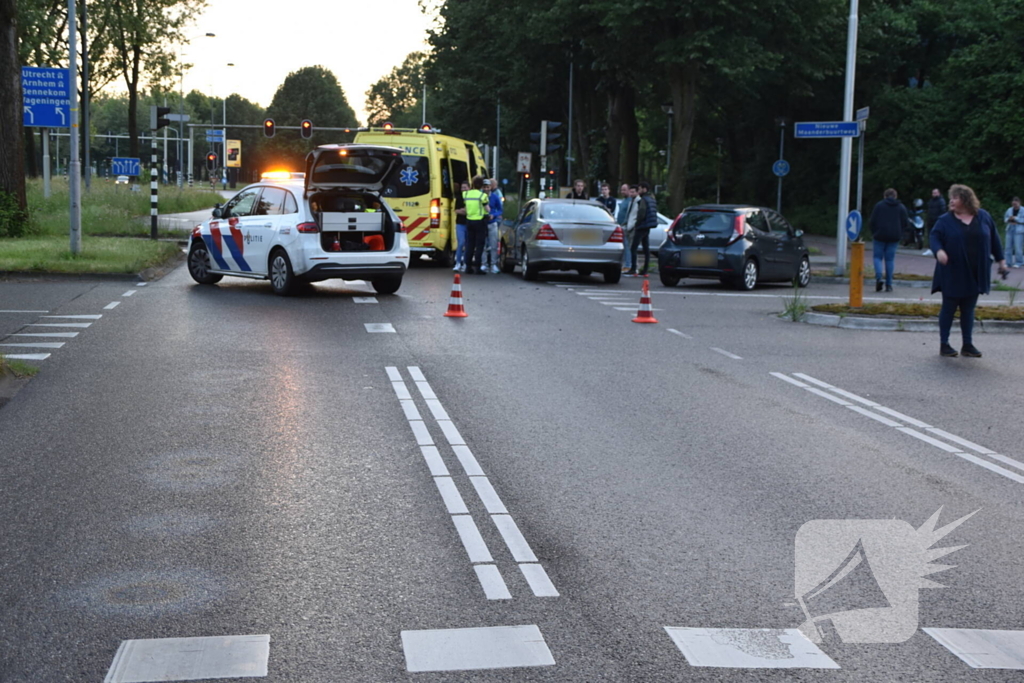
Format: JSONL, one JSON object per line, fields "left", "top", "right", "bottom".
{"left": 266, "top": 67, "right": 357, "bottom": 170}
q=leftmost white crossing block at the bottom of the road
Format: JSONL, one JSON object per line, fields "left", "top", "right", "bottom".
{"left": 103, "top": 635, "right": 270, "bottom": 683}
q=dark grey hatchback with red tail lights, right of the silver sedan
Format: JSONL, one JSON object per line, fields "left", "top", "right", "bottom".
{"left": 657, "top": 204, "right": 811, "bottom": 290}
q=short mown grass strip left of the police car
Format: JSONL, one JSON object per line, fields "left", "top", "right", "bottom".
{"left": 0, "top": 236, "right": 181, "bottom": 274}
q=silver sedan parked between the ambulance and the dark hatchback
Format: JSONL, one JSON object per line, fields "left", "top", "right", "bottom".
{"left": 499, "top": 199, "right": 623, "bottom": 285}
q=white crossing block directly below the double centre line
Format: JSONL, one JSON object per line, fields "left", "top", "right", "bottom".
{"left": 401, "top": 625, "right": 555, "bottom": 672}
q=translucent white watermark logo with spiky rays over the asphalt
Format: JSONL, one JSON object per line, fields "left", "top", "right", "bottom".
{"left": 796, "top": 508, "right": 978, "bottom": 643}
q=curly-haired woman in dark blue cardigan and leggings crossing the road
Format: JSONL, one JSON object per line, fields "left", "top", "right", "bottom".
{"left": 929, "top": 185, "right": 1007, "bottom": 358}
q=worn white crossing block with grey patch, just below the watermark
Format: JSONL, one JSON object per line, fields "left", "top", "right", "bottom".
{"left": 665, "top": 626, "right": 840, "bottom": 669}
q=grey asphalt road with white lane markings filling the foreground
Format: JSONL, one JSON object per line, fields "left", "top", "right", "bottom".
{"left": 0, "top": 268, "right": 1024, "bottom": 683}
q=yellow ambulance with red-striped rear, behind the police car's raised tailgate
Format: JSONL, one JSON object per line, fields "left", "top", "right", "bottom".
{"left": 354, "top": 123, "right": 487, "bottom": 265}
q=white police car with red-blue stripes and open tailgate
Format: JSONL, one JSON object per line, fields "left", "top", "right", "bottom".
{"left": 188, "top": 144, "right": 409, "bottom": 295}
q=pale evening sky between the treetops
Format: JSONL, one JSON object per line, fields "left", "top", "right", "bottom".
{"left": 182, "top": 0, "right": 431, "bottom": 125}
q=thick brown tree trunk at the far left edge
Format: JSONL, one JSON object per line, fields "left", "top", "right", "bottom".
{"left": 0, "top": 0, "right": 27, "bottom": 236}
